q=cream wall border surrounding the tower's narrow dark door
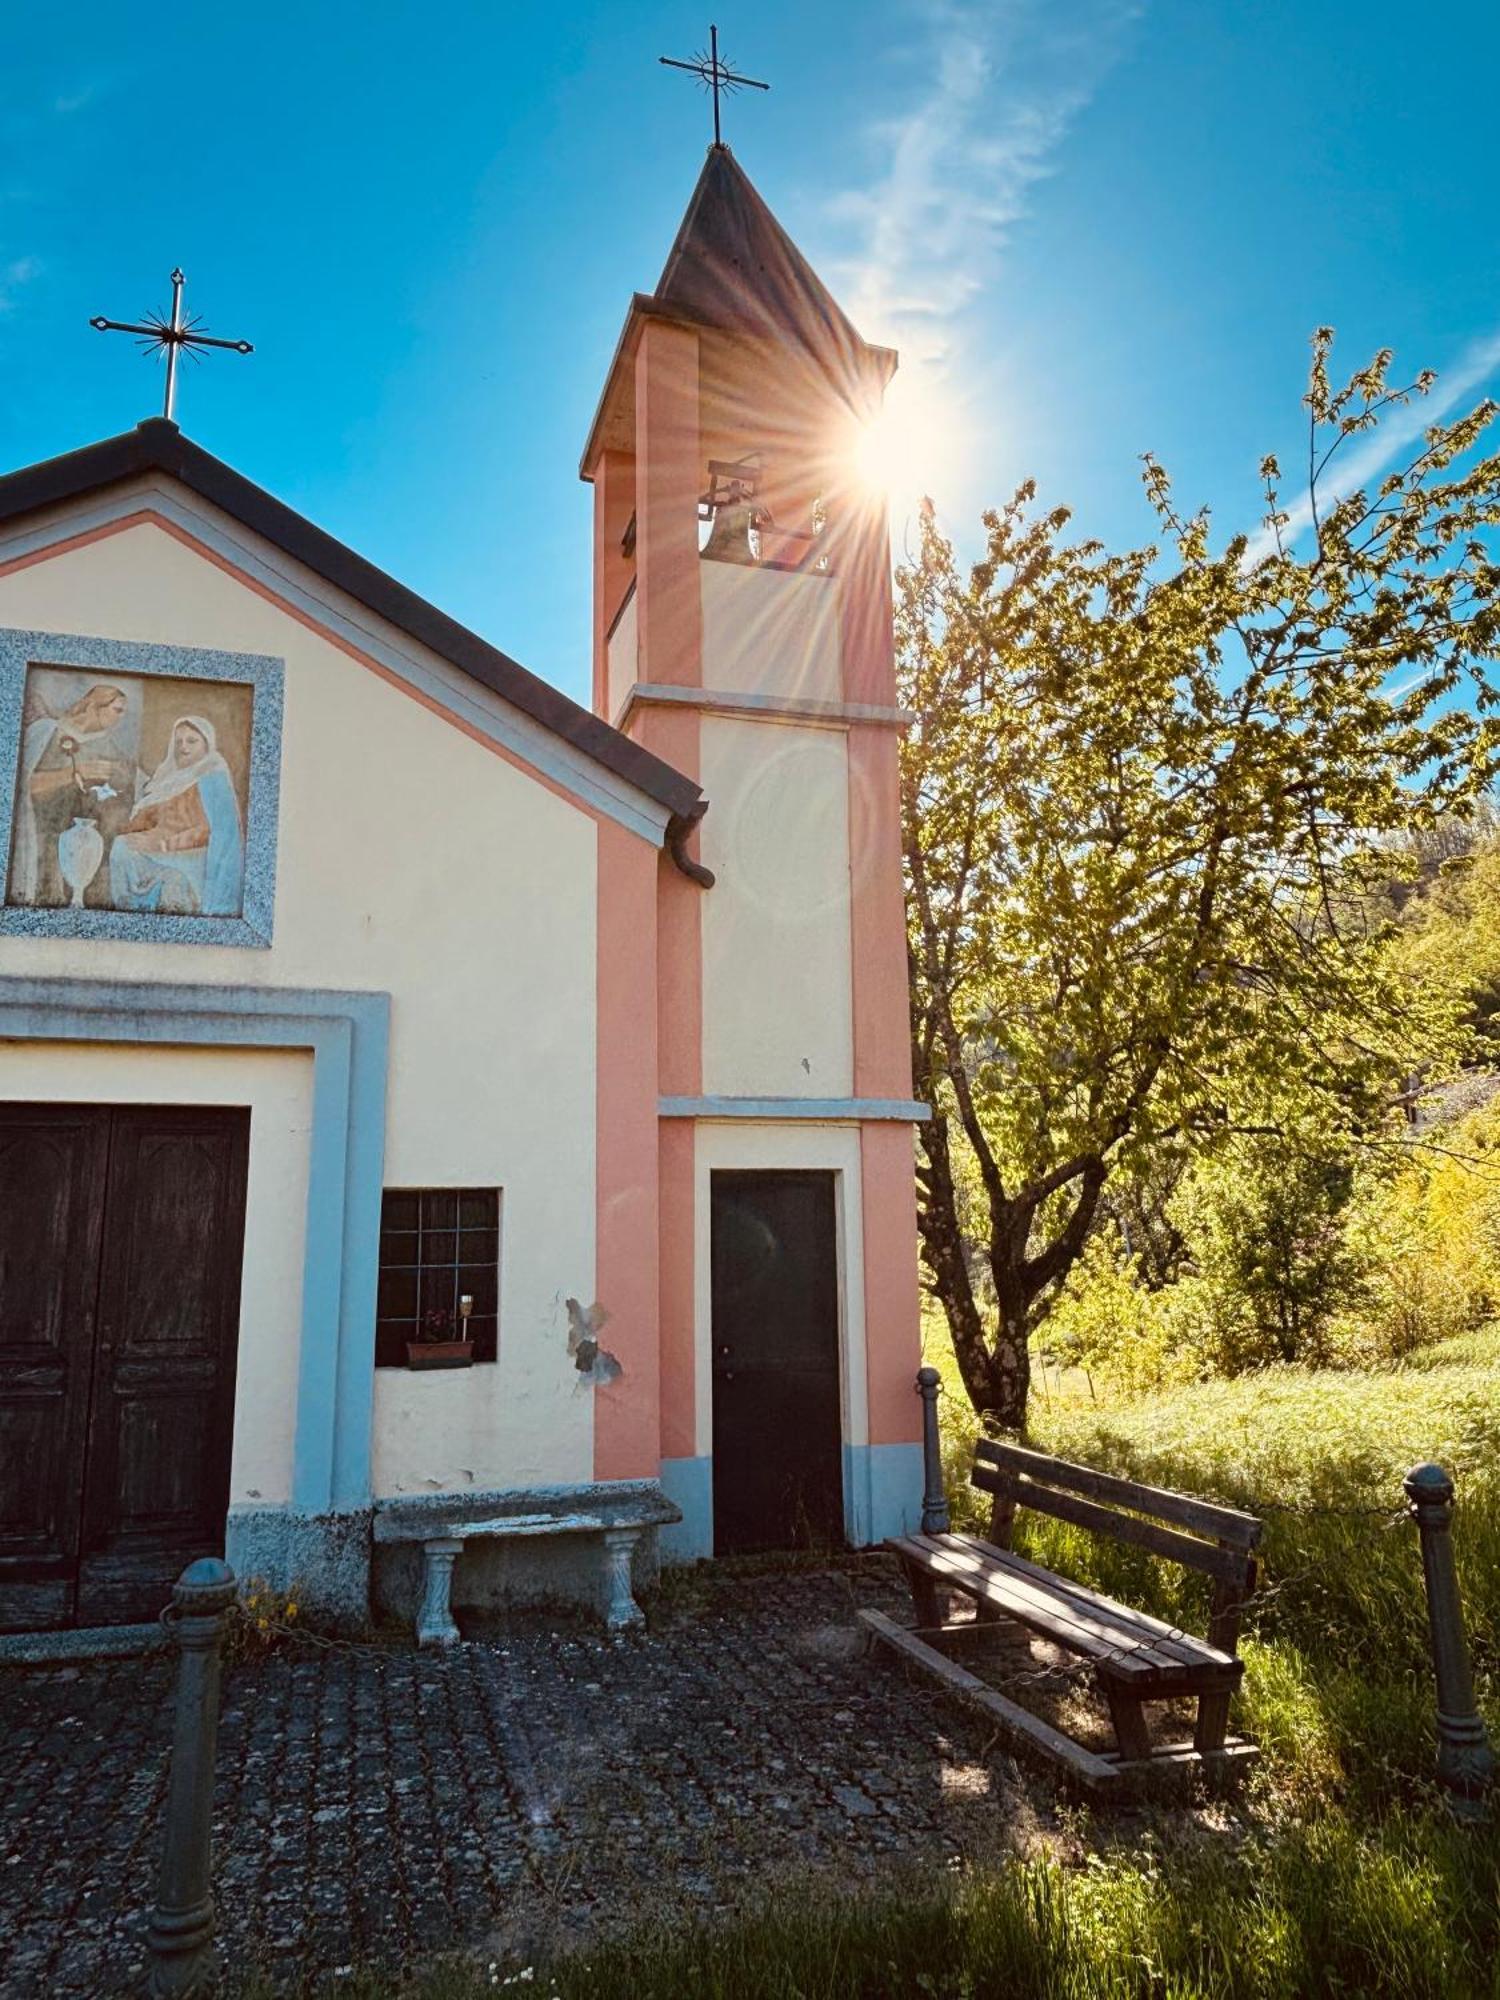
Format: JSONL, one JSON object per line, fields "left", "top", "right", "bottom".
{"left": 692, "top": 1118, "right": 870, "bottom": 1456}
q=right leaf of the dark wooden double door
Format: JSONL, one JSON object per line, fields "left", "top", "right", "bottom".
{"left": 78, "top": 1106, "right": 250, "bottom": 1624}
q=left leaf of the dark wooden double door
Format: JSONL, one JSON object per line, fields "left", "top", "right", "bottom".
{"left": 0, "top": 1104, "right": 110, "bottom": 1632}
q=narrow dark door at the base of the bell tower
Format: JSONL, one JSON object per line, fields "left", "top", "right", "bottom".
{"left": 712, "top": 1172, "right": 844, "bottom": 1554}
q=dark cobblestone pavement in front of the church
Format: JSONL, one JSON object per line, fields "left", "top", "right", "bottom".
{"left": 0, "top": 1558, "right": 1048, "bottom": 2000}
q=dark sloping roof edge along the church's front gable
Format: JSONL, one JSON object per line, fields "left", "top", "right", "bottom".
{"left": 0, "top": 416, "right": 702, "bottom": 816}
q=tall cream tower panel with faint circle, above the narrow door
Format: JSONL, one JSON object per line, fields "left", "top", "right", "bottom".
{"left": 702, "top": 716, "right": 854, "bottom": 1098}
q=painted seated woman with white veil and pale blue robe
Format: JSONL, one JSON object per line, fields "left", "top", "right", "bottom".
{"left": 110, "top": 716, "right": 244, "bottom": 916}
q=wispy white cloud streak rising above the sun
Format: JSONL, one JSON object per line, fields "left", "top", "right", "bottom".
{"left": 836, "top": 0, "right": 1140, "bottom": 364}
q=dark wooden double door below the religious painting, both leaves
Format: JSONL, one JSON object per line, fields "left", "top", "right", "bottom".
{"left": 0, "top": 1104, "right": 250, "bottom": 1632}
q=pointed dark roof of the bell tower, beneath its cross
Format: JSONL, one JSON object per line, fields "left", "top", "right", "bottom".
{"left": 578, "top": 144, "right": 896, "bottom": 478}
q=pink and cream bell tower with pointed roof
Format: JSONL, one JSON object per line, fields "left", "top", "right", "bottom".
{"left": 580, "top": 144, "right": 922, "bottom": 1556}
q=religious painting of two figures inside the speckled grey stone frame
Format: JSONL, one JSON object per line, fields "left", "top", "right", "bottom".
{"left": 6, "top": 666, "right": 254, "bottom": 916}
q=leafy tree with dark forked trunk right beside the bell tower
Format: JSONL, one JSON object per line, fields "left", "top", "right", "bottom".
{"left": 898, "top": 330, "right": 1500, "bottom": 1426}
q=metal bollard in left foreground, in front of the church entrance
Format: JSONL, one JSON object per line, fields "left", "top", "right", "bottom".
{"left": 146, "top": 1556, "right": 234, "bottom": 2000}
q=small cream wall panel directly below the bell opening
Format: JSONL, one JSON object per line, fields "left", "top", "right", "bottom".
{"left": 698, "top": 562, "right": 840, "bottom": 702}
